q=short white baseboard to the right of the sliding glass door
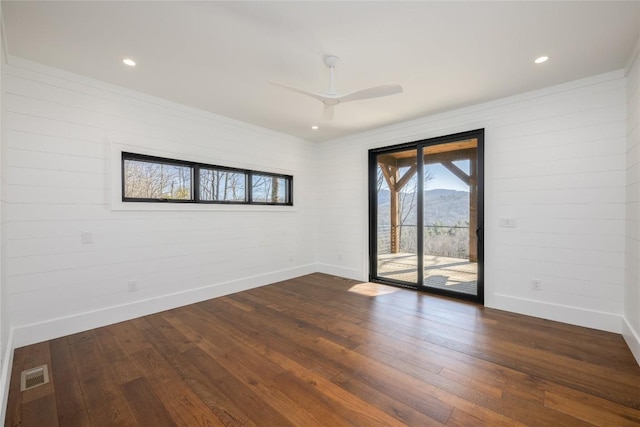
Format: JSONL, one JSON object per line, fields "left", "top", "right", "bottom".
{"left": 486, "top": 294, "right": 622, "bottom": 334}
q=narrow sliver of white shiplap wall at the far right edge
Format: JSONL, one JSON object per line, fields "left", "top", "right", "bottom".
{"left": 622, "top": 40, "right": 640, "bottom": 363}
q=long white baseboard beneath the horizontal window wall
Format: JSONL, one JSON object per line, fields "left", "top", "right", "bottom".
{"left": 11, "top": 264, "right": 317, "bottom": 352}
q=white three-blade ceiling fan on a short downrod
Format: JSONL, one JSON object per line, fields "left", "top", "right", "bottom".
{"left": 269, "top": 55, "right": 402, "bottom": 121}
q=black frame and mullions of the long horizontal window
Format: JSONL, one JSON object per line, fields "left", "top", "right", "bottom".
{"left": 120, "top": 151, "right": 293, "bottom": 206}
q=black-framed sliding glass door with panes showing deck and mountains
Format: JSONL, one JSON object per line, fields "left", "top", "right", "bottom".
{"left": 369, "top": 130, "right": 484, "bottom": 301}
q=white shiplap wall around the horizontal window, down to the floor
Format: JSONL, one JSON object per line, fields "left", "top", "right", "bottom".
{"left": 3, "top": 58, "right": 317, "bottom": 346}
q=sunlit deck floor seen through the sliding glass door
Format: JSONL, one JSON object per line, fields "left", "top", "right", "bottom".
{"left": 378, "top": 253, "right": 478, "bottom": 295}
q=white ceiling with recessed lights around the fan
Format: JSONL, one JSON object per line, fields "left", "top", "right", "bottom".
{"left": 2, "top": 0, "right": 640, "bottom": 141}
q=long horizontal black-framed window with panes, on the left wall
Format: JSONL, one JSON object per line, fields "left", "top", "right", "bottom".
{"left": 122, "top": 152, "right": 293, "bottom": 206}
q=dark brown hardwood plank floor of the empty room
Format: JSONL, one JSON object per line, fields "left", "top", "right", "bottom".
{"left": 5, "top": 274, "right": 640, "bottom": 427}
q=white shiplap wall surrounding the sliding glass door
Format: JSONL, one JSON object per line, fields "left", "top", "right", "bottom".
{"left": 319, "top": 71, "right": 626, "bottom": 332}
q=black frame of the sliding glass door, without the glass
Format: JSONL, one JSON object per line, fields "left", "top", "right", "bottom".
{"left": 368, "top": 129, "right": 484, "bottom": 304}
